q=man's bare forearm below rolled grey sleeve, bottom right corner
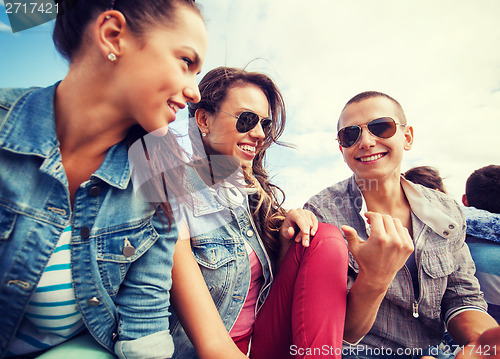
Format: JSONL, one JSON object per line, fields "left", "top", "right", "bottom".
{"left": 448, "top": 310, "right": 498, "bottom": 345}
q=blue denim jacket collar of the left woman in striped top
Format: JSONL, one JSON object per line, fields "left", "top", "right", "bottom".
{"left": 0, "top": 82, "right": 130, "bottom": 189}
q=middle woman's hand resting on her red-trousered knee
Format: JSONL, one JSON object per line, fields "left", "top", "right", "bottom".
{"left": 280, "top": 208, "right": 318, "bottom": 247}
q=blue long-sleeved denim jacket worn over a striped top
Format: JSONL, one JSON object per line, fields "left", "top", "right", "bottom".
{"left": 0, "top": 84, "right": 177, "bottom": 358}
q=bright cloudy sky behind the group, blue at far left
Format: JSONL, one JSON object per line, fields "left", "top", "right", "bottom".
{"left": 0, "top": 0, "right": 500, "bottom": 207}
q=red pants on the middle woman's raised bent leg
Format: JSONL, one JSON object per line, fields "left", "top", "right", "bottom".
{"left": 250, "top": 223, "right": 348, "bottom": 359}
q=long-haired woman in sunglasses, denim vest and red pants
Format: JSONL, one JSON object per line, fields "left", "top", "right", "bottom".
{"left": 170, "top": 67, "right": 347, "bottom": 359}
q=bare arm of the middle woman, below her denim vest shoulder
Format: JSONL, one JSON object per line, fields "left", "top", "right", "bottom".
{"left": 170, "top": 223, "right": 246, "bottom": 359}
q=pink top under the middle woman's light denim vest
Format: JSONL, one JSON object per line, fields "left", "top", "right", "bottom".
{"left": 229, "top": 250, "right": 264, "bottom": 338}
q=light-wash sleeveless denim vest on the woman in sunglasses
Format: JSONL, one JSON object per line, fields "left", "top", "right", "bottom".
{"left": 170, "top": 170, "right": 273, "bottom": 358}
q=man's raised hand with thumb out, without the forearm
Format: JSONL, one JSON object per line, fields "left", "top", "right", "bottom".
{"left": 341, "top": 212, "right": 414, "bottom": 290}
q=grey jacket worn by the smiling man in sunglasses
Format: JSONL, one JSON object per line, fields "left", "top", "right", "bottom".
{"left": 304, "top": 176, "right": 486, "bottom": 350}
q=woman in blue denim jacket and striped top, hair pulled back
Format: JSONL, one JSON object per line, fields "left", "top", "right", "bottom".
{"left": 0, "top": 0, "right": 207, "bottom": 358}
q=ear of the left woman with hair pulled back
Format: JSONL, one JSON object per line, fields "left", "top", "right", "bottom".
{"left": 95, "top": 10, "right": 127, "bottom": 58}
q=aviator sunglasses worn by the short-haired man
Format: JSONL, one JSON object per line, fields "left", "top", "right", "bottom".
{"left": 337, "top": 117, "right": 406, "bottom": 148}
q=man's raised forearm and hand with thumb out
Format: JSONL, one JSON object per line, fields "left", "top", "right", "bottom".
{"left": 342, "top": 212, "right": 414, "bottom": 343}
